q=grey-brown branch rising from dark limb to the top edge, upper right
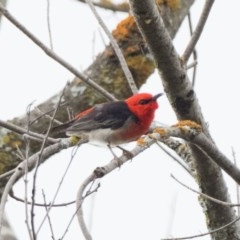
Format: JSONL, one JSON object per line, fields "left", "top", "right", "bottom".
{"left": 181, "top": 0, "right": 214, "bottom": 63}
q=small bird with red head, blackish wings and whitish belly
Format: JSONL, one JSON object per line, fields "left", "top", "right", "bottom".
{"left": 53, "top": 93, "right": 162, "bottom": 146}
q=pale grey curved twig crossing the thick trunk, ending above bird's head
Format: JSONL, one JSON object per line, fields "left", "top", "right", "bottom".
{"left": 86, "top": 0, "right": 138, "bottom": 94}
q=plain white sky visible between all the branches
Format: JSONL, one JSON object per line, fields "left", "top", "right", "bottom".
{"left": 0, "top": 0, "right": 240, "bottom": 240}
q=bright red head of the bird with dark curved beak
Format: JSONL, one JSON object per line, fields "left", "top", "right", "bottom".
{"left": 125, "top": 93, "right": 162, "bottom": 127}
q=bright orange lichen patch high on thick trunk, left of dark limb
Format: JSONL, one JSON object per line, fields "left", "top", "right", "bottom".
{"left": 112, "top": 16, "right": 136, "bottom": 40}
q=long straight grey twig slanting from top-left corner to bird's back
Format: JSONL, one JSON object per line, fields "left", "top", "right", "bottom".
{"left": 0, "top": 3, "right": 117, "bottom": 101}
